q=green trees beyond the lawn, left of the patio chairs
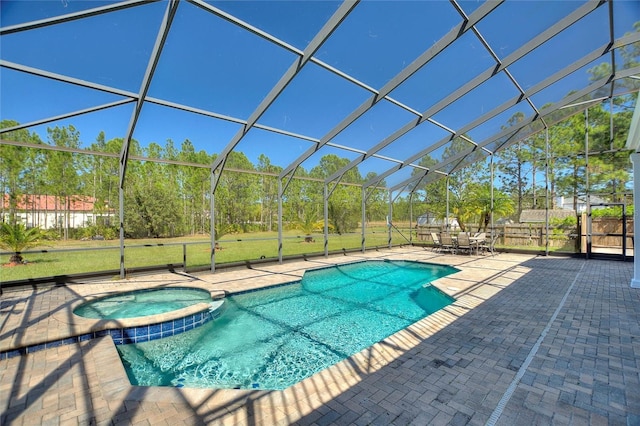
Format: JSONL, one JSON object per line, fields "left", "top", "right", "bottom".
{"left": 0, "top": 120, "right": 387, "bottom": 239}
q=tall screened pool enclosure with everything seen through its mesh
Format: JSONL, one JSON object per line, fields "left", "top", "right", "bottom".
{"left": 0, "top": 0, "right": 640, "bottom": 282}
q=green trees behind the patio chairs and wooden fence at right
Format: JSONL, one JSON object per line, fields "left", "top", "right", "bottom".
{"left": 414, "top": 95, "right": 635, "bottom": 230}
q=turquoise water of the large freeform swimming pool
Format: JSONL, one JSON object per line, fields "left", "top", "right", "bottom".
{"left": 117, "top": 261, "right": 457, "bottom": 390}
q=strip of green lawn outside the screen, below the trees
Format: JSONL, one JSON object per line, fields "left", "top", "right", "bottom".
{"left": 0, "top": 228, "right": 408, "bottom": 282}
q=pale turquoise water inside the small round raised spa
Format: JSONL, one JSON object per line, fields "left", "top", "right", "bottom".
{"left": 73, "top": 287, "right": 211, "bottom": 319}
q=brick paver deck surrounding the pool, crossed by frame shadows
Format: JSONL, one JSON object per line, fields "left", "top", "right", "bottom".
{"left": 0, "top": 247, "right": 640, "bottom": 425}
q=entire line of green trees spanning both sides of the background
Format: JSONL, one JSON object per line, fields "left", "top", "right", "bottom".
{"left": 0, "top": 88, "right": 634, "bottom": 239}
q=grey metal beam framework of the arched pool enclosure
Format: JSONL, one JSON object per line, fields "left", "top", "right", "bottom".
{"left": 0, "top": 0, "right": 640, "bottom": 275}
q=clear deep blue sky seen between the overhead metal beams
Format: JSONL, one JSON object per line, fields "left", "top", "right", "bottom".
{"left": 0, "top": 0, "right": 640, "bottom": 186}
